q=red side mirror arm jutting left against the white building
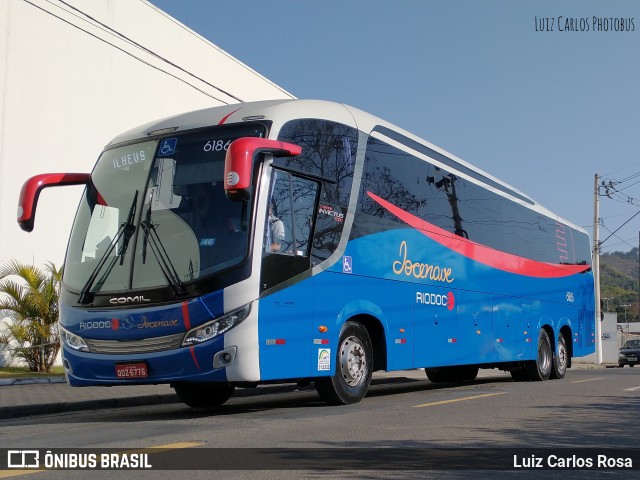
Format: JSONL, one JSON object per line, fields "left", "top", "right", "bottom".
{"left": 18, "top": 173, "right": 91, "bottom": 232}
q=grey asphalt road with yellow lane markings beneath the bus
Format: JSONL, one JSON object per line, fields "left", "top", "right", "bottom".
{"left": 0, "top": 368, "right": 640, "bottom": 479}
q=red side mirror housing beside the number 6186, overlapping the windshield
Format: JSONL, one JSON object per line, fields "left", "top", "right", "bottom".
{"left": 224, "top": 137, "right": 302, "bottom": 201}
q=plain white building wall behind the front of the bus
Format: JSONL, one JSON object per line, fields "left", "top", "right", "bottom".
{"left": 0, "top": 0, "right": 293, "bottom": 365}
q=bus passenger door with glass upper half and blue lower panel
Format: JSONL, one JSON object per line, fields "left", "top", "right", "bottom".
{"left": 258, "top": 169, "right": 319, "bottom": 380}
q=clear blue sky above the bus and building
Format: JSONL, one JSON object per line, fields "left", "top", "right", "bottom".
{"left": 150, "top": 0, "right": 640, "bottom": 252}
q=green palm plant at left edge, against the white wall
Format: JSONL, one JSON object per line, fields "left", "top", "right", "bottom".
{"left": 0, "top": 260, "right": 62, "bottom": 372}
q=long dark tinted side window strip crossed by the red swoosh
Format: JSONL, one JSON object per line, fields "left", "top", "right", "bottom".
{"left": 351, "top": 137, "right": 590, "bottom": 264}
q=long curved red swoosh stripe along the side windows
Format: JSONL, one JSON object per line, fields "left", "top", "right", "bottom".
{"left": 367, "top": 192, "right": 591, "bottom": 278}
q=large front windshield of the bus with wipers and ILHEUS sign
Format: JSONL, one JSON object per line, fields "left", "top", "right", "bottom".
{"left": 64, "top": 125, "right": 266, "bottom": 296}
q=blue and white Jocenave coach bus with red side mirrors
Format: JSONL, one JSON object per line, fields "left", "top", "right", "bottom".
{"left": 18, "top": 100, "right": 595, "bottom": 407}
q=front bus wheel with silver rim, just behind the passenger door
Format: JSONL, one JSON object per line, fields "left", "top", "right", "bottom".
{"left": 315, "top": 322, "right": 373, "bottom": 405}
